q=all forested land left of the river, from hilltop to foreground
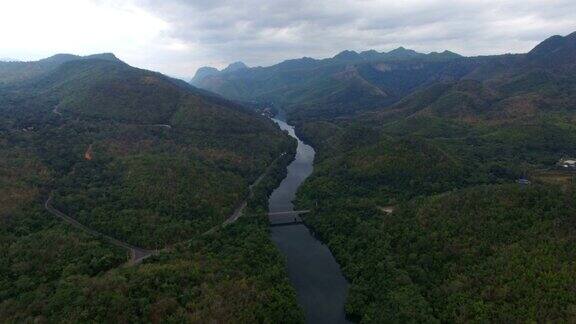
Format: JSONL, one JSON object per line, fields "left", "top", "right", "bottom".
{"left": 0, "top": 55, "right": 301, "bottom": 322}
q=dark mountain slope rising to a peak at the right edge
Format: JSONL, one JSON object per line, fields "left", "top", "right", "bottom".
{"left": 370, "top": 34, "right": 576, "bottom": 123}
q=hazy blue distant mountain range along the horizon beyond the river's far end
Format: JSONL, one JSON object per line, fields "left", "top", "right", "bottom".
{"left": 192, "top": 34, "right": 575, "bottom": 120}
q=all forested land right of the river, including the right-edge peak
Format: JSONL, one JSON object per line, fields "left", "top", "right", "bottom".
{"left": 290, "top": 30, "right": 576, "bottom": 323}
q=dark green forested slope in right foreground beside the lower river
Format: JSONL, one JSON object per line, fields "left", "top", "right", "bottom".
{"left": 306, "top": 185, "right": 576, "bottom": 323}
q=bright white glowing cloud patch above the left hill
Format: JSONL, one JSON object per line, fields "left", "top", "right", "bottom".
{"left": 0, "top": 0, "right": 168, "bottom": 60}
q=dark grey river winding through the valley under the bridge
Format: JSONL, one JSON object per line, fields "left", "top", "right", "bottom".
{"left": 268, "top": 119, "right": 349, "bottom": 324}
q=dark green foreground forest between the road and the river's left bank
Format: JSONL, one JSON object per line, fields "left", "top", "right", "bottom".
{"left": 0, "top": 145, "right": 303, "bottom": 323}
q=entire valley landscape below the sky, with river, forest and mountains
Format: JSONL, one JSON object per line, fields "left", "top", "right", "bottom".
{"left": 0, "top": 26, "right": 576, "bottom": 323}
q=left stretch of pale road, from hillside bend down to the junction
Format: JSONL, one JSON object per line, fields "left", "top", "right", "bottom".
{"left": 44, "top": 195, "right": 157, "bottom": 265}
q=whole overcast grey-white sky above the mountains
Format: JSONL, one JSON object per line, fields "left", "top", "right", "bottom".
{"left": 0, "top": 0, "right": 576, "bottom": 78}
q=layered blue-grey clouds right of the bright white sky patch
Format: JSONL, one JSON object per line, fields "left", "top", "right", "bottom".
{"left": 130, "top": 0, "right": 576, "bottom": 72}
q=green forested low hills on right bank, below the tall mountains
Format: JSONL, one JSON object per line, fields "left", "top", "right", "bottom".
{"left": 298, "top": 112, "right": 576, "bottom": 323}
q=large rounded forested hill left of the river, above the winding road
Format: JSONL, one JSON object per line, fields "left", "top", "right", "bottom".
{"left": 0, "top": 52, "right": 291, "bottom": 247}
